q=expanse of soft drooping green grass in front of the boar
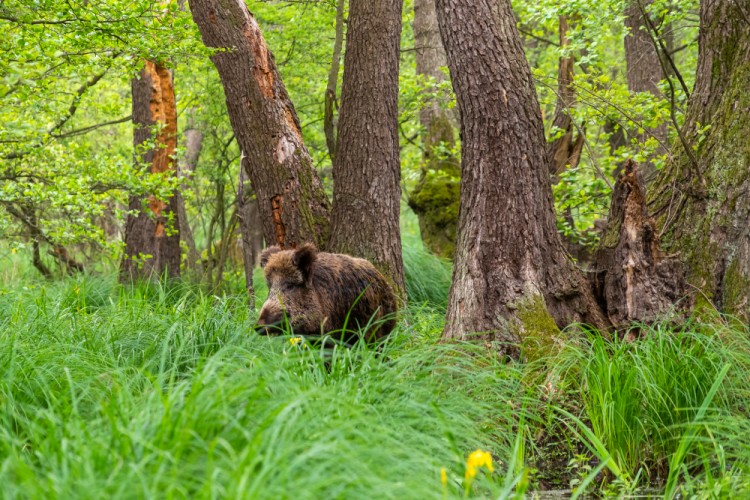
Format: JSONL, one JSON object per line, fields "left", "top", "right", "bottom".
{"left": 0, "top": 278, "right": 520, "bottom": 498}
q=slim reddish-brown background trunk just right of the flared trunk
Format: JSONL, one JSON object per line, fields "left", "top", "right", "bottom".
{"left": 547, "top": 16, "right": 584, "bottom": 182}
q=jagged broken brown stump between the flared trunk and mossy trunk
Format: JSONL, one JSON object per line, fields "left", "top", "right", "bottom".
{"left": 593, "top": 161, "right": 686, "bottom": 328}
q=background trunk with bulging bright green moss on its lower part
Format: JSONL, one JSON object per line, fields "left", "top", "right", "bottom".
{"left": 409, "top": 0, "right": 461, "bottom": 259}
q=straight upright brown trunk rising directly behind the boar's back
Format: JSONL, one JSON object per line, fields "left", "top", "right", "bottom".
{"left": 328, "top": 0, "right": 405, "bottom": 297}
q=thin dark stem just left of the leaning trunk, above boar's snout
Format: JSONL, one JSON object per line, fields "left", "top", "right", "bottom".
{"left": 237, "top": 162, "right": 263, "bottom": 309}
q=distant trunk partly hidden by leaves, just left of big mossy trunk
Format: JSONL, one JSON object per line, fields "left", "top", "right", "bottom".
{"left": 625, "top": 0, "right": 668, "bottom": 183}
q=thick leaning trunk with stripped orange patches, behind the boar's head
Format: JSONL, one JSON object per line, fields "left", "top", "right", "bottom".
{"left": 189, "top": 0, "right": 330, "bottom": 247}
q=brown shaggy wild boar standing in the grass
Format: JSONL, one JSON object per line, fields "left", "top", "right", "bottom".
{"left": 258, "top": 244, "right": 397, "bottom": 342}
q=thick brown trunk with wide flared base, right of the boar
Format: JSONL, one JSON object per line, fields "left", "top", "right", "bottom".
{"left": 437, "top": 0, "right": 607, "bottom": 357}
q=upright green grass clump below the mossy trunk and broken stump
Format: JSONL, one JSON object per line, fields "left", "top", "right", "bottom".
{"left": 555, "top": 324, "right": 750, "bottom": 496}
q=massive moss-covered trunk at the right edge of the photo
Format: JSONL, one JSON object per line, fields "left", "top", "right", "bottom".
{"left": 649, "top": 0, "right": 750, "bottom": 320}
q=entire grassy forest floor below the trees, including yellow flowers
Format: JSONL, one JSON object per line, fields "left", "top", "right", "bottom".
{"left": 0, "top": 240, "right": 750, "bottom": 499}
